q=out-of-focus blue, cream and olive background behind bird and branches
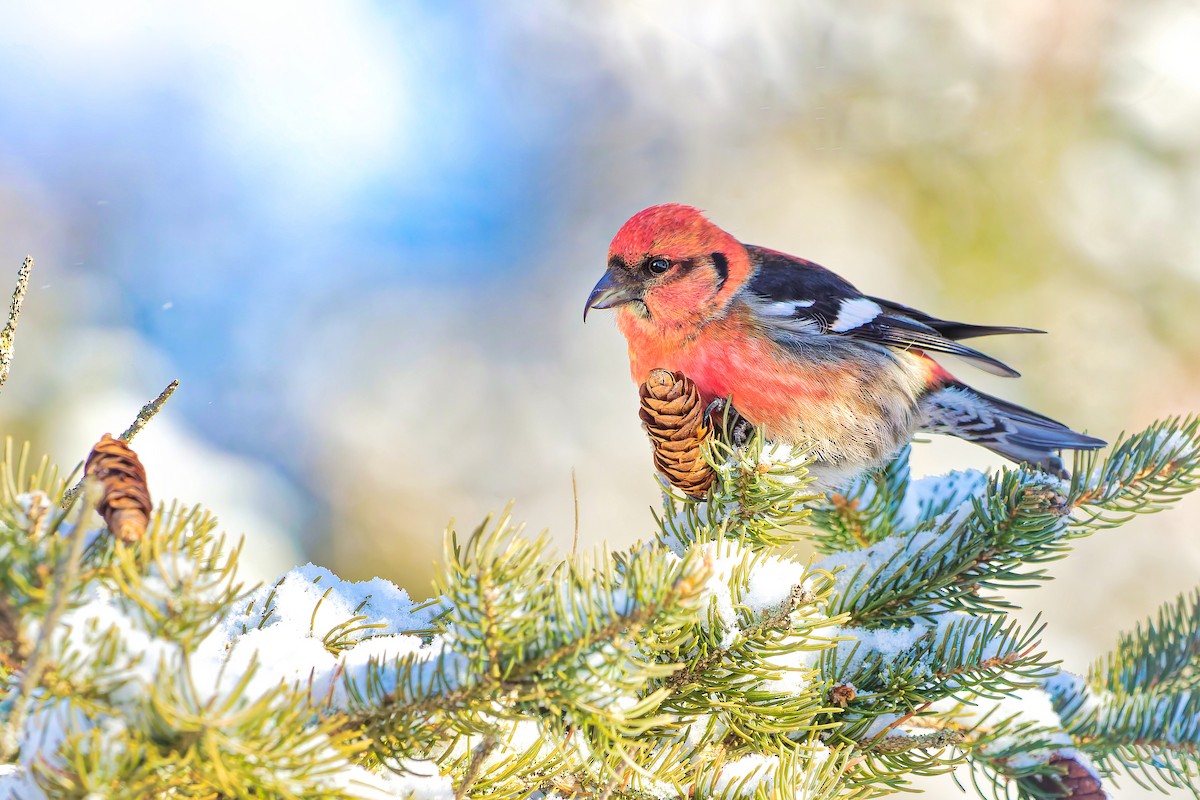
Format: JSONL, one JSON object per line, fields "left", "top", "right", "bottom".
{"left": 0, "top": 0, "right": 1200, "bottom": 790}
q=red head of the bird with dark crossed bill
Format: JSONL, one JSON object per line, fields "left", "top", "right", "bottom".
{"left": 583, "top": 203, "right": 750, "bottom": 327}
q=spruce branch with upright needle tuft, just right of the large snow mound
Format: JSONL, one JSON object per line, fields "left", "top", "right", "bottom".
{"left": 349, "top": 525, "right": 703, "bottom": 754}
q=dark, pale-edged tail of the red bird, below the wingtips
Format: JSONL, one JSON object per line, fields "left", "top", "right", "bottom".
{"left": 922, "top": 383, "right": 1105, "bottom": 476}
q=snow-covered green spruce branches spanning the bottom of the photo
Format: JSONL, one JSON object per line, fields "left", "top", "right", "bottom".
{"left": 0, "top": 379, "right": 1200, "bottom": 800}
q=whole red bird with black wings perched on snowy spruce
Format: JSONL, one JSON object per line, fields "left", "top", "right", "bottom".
{"left": 583, "top": 204, "right": 1104, "bottom": 485}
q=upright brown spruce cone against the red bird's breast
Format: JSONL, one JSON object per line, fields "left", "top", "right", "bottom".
{"left": 638, "top": 369, "right": 715, "bottom": 498}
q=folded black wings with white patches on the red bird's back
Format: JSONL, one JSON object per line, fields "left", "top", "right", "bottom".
{"left": 746, "top": 246, "right": 1040, "bottom": 378}
